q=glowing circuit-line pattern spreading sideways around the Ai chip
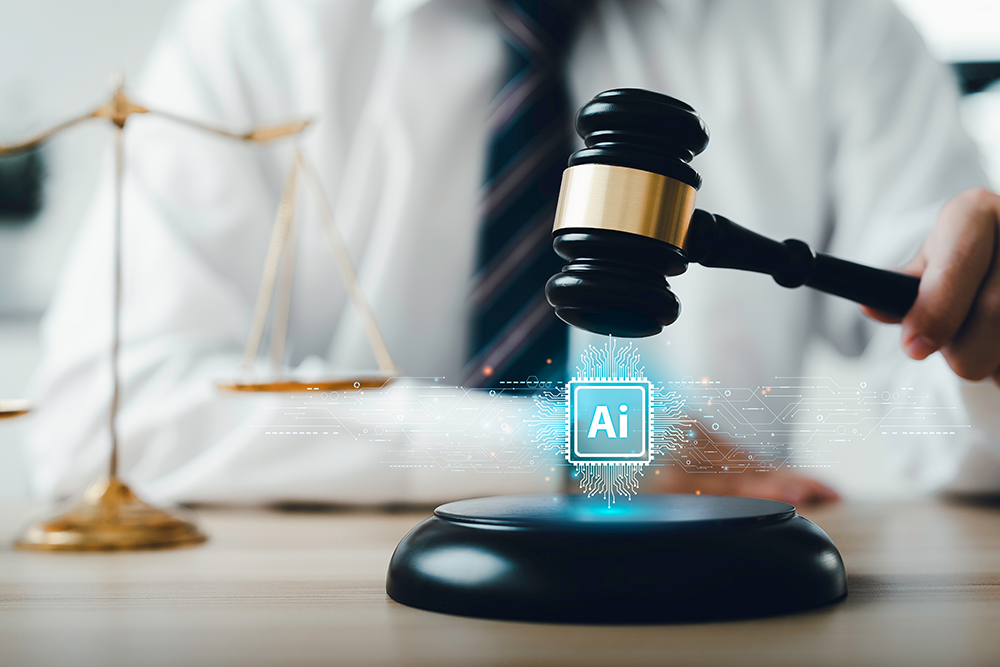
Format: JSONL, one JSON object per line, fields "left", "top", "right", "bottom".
{"left": 251, "top": 370, "right": 969, "bottom": 486}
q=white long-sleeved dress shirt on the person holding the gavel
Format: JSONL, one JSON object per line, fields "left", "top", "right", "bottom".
{"left": 23, "top": 0, "right": 1000, "bottom": 502}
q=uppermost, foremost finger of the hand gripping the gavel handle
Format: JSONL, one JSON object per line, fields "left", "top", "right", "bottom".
{"left": 903, "top": 190, "right": 1000, "bottom": 359}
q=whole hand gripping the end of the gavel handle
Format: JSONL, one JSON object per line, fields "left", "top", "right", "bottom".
{"left": 862, "top": 188, "right": 1000, "bottom": 385}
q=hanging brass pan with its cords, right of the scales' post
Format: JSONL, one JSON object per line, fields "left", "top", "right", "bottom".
{"left": 216, "top": 149, "right": 402, "bottom": 393}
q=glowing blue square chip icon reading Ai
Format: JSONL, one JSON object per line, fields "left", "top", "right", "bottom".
{"left": 568, "top": 380, "right": 652, "bottom": 463}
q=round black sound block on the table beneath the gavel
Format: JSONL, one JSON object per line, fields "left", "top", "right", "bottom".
{"left": 386, "top": 494, "right": 847, "bottom": 623}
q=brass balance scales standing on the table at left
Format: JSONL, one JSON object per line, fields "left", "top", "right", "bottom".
{"left": 0, "top": 76, "right": 401, "bottom": 551}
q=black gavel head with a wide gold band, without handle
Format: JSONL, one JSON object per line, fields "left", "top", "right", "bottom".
{"left": 545, "top": 89, "right": 708, "bottom": 338}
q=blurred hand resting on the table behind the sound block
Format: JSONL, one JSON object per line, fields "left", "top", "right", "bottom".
{"left": 643, "top": 467, "right": 840, "bottom": 506}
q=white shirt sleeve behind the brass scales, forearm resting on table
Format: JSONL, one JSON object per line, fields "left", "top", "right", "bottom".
{"left": 28, "top": 1, "right": 554, "bottom": 503}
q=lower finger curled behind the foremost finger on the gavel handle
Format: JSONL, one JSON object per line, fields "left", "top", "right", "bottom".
{"left": 941, "top": 239, "right": 1000, "bottom": 382}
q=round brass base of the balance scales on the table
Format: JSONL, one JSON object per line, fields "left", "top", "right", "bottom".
{"left": 14, "top": 477, "right": 206, "bottom": 551}
